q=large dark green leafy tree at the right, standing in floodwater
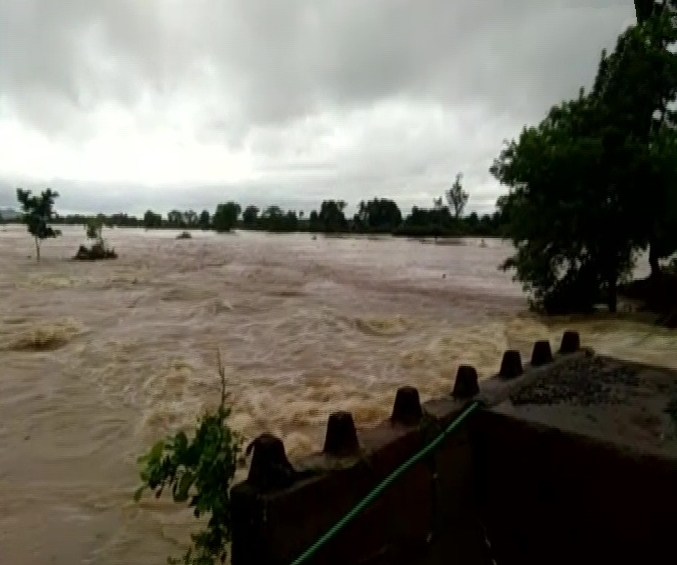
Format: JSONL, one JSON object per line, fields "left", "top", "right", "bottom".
{"left": 490, "top": 8, "right": 677, "bottom": 314}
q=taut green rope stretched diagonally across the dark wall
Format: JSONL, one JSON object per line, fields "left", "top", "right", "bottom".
{"left": 292, "top": 400, "right": 482, "bottom": 565}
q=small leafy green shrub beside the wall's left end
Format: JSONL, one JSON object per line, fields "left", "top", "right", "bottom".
{"left": 134, "top": 355, "right": 241, "bottom": 565}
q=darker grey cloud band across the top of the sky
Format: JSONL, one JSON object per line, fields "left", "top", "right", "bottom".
{"left": 0, "top": 0, "right": 633, "bottom": 132}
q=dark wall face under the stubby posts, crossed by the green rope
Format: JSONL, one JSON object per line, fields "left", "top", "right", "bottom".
{"left": 232, "top": 390, "right": 480, "bottom": 565}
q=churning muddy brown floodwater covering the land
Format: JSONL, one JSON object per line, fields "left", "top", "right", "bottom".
{"left": 0, "top": 226, "right": 677, "bottom": 565}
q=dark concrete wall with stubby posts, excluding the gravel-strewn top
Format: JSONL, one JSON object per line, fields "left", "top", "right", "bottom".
{"left": 232, "top": 332, "right": 677, "bottom": 565}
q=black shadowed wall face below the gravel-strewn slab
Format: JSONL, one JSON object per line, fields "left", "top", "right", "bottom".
{"left": 474, "top": 411, "right": 677, "bottom": 565}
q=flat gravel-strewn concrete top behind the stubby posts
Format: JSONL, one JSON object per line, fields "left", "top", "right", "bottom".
{"left": 486, "top": 352, "right": 677, "bottom": 457}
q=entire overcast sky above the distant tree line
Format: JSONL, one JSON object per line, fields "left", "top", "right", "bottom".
{"left": 0, "top": 0, "right": 634, "bottom": 213}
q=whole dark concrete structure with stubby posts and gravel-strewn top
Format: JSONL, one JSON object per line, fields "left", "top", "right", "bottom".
{"left": 232, "top": 335, "right": 677, "bottom": 565}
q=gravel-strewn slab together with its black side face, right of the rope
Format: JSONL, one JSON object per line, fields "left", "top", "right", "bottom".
{"left": 473, "top": 351, "right": 677, "bottom": 565}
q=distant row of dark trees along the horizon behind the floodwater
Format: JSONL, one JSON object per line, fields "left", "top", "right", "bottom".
{"left": 0, "top": 174, "right": 502, "bottom": 237}
